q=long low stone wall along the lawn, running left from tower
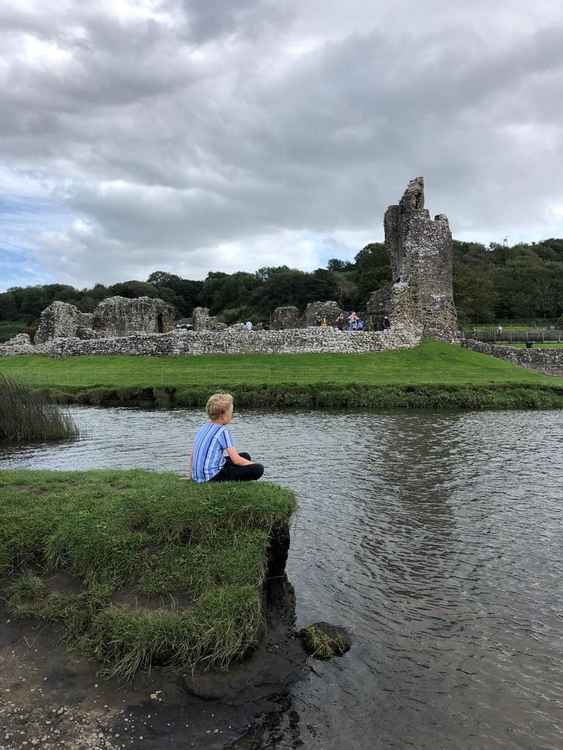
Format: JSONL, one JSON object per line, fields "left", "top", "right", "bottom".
{"left": 27, "top": 327, "right": 420, "bottom": 357}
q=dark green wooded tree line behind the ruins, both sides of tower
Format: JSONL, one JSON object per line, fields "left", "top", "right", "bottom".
{"left": 0, "top": 239, "right": 563, "bottom": 325}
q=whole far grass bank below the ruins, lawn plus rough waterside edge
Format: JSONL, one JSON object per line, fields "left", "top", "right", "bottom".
{"left": 0, "top": 341, "right": 563, "bottom": 409}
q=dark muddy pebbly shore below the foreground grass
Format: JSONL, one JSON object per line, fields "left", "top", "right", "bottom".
{"left": 0, "top": 577, "right": 306, "bottom": 750}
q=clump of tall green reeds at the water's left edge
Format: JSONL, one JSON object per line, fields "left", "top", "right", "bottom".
{"left": 0, "top": 373, "right": 78, "bottom": 443}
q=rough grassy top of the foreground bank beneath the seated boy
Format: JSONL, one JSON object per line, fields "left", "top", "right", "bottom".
{"left": 0, "top": 471, "right": 295, "bottom": 678}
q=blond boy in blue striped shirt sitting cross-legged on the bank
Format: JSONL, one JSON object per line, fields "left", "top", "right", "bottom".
{"left": 192, "top": 393, "right": 264, "bottom": 483}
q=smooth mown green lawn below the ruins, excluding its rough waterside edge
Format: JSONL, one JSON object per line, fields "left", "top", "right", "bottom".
{"left": 0, "top": 341, "right": 563, "bottom": 389}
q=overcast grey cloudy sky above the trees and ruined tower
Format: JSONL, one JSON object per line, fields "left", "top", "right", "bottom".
{"left": 0, "top": 0, "right": 563, "bottom": 289}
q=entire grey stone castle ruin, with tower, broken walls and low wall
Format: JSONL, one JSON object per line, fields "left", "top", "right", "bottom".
{"left": 0, "top": 177, "right": 457, "bottom": 356}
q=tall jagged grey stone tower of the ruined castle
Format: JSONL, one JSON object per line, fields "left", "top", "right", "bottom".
{"left": 367, "top": 177, "right": 457, "bottom": 339}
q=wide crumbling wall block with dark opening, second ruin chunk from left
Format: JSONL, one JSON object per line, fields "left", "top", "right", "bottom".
{"left": 92, "top": 297, "right": 175, "bottom": 336}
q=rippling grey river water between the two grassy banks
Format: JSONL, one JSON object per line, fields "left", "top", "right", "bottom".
{"left": 0, "top": 408, "right": 563, "bottom": 750}
